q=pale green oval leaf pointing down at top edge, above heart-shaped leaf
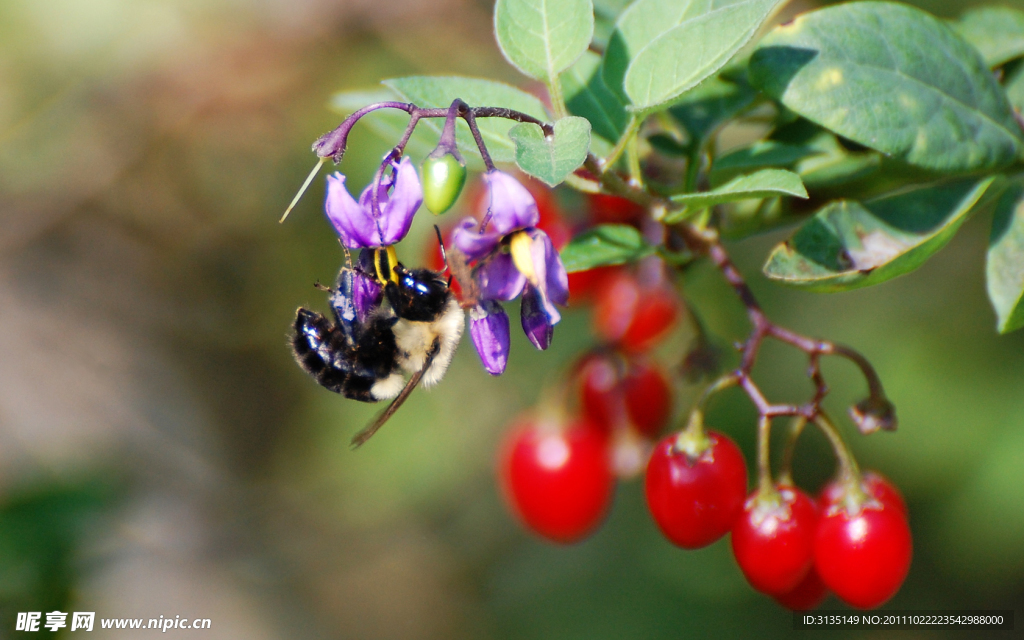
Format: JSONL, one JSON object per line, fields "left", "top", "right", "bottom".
{"left": 495, "top": 0, "right": 594, "bottom": 84}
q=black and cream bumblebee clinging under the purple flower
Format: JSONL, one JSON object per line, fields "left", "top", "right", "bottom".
{"left": 292, "top": 248, "right": 464, "bottom": 446}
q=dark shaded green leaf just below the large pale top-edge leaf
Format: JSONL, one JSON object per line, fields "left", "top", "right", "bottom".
{"left": 669, "top": 78, "right": 757, "bottom": 145}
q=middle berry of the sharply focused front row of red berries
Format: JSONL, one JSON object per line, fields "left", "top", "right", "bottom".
{"left": 732, "top": 486, "right": 818, "bottom": 596}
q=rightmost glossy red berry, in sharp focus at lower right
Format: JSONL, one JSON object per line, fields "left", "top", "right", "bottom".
{"left": 814, "top": 501, "right": 913, "bottom": 609}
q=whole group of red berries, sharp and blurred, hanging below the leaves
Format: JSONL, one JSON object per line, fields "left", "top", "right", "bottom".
{"left": 491, "top": 188, "right": 912, "bottom": 610}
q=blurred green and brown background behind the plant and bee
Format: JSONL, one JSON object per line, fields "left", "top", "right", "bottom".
{"left": 0, "top": 0, "right": 1024, "bottom": 640}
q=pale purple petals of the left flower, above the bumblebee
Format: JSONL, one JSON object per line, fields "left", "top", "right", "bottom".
{"left": 327, "top": 158, "right": 423, "bottom": 249}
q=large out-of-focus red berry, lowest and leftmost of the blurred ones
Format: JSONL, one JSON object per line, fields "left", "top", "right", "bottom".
{"left": 501, "top": 413, "right": 612, "bottom": 543}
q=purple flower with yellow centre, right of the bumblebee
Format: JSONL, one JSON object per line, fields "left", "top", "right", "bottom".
{"left": 452, "top": 171, "right": 569, "bottom": 368}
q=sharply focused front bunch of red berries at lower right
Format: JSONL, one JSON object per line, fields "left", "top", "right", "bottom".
{"left": 645, "top": 413, "right": 912, "bottom": 609}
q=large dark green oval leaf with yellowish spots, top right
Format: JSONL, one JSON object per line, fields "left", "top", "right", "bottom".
{"left": 750, "top": 2, "right": 1021, "bottom": 171}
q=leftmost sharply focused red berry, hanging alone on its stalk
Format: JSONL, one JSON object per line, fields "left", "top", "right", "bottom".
{"left": 644, "top": 431, "right": 746, "bottom": 549}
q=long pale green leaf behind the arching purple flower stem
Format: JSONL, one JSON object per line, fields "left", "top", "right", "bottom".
{"left": 383, "top": 76, "right": 548, "bottom": 162}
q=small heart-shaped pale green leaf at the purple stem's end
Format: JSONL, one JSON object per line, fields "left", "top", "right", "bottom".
{"left": 509, "top": 116, "right": 590, "bottom": 186}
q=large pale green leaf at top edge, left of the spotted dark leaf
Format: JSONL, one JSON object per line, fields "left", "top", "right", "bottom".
{"left": 606, "top": 0, "right": 780, "bottom": 112}
